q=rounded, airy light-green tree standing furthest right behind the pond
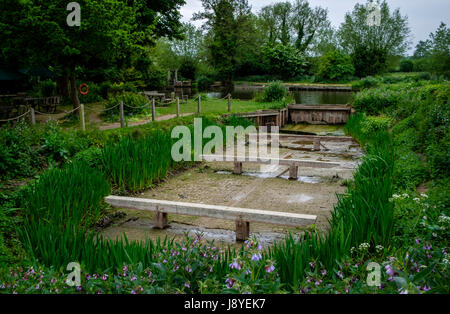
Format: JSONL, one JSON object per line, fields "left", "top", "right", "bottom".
{"left": 338, "top": 0, "right": 410, "bottom": 77}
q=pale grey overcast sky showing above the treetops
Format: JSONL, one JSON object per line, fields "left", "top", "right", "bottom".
{"left": 181, "top": 0, "right": 450, "bottom": 52}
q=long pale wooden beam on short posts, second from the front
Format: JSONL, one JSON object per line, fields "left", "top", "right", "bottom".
{"left": 200, "top": 155, "right": 341, "bottom": 180}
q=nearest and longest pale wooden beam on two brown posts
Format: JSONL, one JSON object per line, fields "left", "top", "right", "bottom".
{"left": 105, "top": 196, "right": 317, "bottom": 241}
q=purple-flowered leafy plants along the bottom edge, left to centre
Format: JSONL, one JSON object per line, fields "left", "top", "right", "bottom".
{"left": 0, "top": 234, "right": 280, "bottom": 294}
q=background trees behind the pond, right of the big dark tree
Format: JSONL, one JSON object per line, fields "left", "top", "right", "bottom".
{"left": 161, "top": 0, "right": 422, "bottom": 81}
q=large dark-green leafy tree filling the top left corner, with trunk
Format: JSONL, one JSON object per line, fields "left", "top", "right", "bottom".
{"left": 0, "top": 0, "right": 184, "bottom": 108}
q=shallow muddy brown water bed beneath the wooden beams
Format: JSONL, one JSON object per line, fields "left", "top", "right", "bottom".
{"left": 103, "top": 141, "right": 362, "bottom": 246}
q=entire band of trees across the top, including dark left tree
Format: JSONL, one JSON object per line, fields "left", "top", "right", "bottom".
{"left": 0, "top": 0, "right": 449, "bottom": 102}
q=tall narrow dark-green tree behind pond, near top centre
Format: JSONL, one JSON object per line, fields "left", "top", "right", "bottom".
{"left": 194, "top": 0, "right": 251, "bottom": 83}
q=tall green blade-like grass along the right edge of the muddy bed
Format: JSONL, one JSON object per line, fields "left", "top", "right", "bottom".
{"left": 269, "top": 115, "right": 394, "bottom": 291}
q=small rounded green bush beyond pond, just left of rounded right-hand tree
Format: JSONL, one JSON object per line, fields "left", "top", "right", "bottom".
{"left": 317, "top": 50, "right": 355, "bottom": 81}
